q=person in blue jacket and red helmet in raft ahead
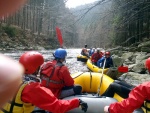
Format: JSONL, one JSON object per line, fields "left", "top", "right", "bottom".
{"left": 97, "top": 52, "right": 113, "bottom": 68}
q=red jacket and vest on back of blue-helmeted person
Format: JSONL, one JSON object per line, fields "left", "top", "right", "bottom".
{"left": 40, "top": 60, "right": 64, "bottom": 89}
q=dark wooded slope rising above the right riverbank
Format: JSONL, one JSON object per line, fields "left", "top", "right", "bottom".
{"left": 75, "top": 0, "right": 150, "bottom": 47}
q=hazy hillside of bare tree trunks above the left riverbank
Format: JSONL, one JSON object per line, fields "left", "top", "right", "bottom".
{"left": 1, "top": 0, "right": 76, "bottom": 47}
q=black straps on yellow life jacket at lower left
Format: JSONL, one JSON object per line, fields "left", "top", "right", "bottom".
{"left": 1, "top": 83, "right": 24, "bottom": 113}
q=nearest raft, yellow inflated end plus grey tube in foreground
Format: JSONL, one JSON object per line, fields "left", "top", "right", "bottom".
{"left": 70, "top": 72, "right": 146, "bottom": 113}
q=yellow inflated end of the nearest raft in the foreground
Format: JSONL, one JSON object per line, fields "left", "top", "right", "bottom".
{"left": 72, "top": 72, "right": 123, "bottom": 101}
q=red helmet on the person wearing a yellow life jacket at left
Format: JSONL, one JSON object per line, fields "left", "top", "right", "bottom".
{"left": 19, "top": 51, "right": 44, "bottom": 74}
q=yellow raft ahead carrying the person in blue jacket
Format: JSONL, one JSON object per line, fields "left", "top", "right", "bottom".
{"left": 86, "top": 59, "right": 108, "bottom": 74}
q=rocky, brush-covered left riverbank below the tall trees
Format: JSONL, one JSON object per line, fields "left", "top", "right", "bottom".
{"left": 0, "top": 25, "right": 59, "bottom": 51}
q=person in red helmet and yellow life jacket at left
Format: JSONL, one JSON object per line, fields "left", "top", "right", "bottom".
{"left": 0, "top": 51, "right": 88, "bottom": 113}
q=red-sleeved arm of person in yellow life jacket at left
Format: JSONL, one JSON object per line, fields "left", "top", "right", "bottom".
{"left": 21, "top": 83, "right": 80, "bottom": 113}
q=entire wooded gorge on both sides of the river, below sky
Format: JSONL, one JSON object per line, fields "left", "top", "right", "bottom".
{"left": 0, "top": 0, "right": 150, "bottom": 48}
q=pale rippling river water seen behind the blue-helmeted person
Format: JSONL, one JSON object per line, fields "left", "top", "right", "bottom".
{"left": 2, "top": 49, "right": 88, "bottom": 73}
